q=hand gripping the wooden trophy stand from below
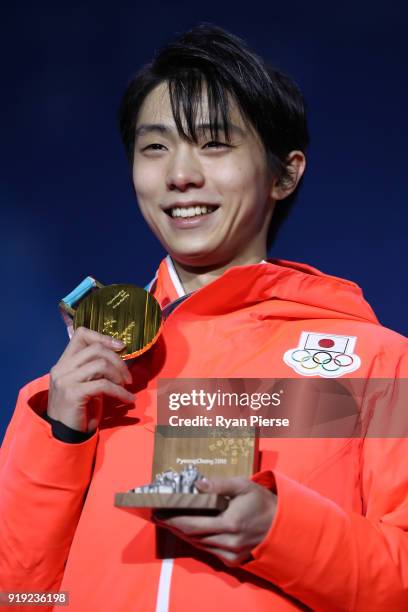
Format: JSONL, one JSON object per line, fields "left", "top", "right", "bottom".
{"left": 155, "top": 477, "right": 277, "bottom": 567}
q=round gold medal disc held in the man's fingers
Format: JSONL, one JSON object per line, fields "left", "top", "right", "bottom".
{"left": 74, "top": 285, "right": 162, "bottom": 360}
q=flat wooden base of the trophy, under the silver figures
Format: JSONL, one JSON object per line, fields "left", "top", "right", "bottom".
{"left": 115, "top": 493, "right": 229, "bottom": 513}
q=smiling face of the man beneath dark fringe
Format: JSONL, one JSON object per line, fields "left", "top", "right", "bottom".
{"left": 133, "top": 83, "right": 274, "bottom": 266}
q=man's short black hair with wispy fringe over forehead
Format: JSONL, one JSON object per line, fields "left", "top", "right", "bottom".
{"left": 119, "top": 24, "right": 309, "bottom": 247}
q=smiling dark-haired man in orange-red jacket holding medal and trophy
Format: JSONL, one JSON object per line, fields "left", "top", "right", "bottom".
{"left": 1, "top": 26, "right": 408, "bottom": 612}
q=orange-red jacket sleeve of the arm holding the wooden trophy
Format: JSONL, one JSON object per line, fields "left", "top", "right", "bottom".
{"left": 243, "top": 368, "right": 408, "bottom": 612}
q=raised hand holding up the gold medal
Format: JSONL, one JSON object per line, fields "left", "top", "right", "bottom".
{"left": 47, "top": 327, "right": 135, "bottom": 433}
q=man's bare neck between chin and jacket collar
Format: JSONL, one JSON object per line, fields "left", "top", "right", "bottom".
{"left": 172, "top": 253, "right": 266, "bottom": 293}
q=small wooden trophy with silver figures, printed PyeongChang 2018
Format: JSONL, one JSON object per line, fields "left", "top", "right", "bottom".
{"left": 115, "top": 425, "right": 257, "bottom": 514}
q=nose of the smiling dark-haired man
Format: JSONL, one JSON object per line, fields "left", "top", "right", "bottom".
{"left": 166, "top": 144, "right": 204, "bottom": 191}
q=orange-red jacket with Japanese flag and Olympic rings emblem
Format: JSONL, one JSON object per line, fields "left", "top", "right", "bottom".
{"left": 0, "top": 258, "right": 408, "bottom": 612}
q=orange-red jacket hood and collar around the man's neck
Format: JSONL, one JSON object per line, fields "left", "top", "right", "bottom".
{"left": 149, "top": 256, "right": 379, "bottom": 324}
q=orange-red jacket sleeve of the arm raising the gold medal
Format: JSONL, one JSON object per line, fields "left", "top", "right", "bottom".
{"left": 0, "top": 378, "right": 98, "bottom": 591}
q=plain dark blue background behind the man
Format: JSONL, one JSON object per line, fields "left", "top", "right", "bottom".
{"left": 0, "top": 0, "right": 408, "bottom": 440}
